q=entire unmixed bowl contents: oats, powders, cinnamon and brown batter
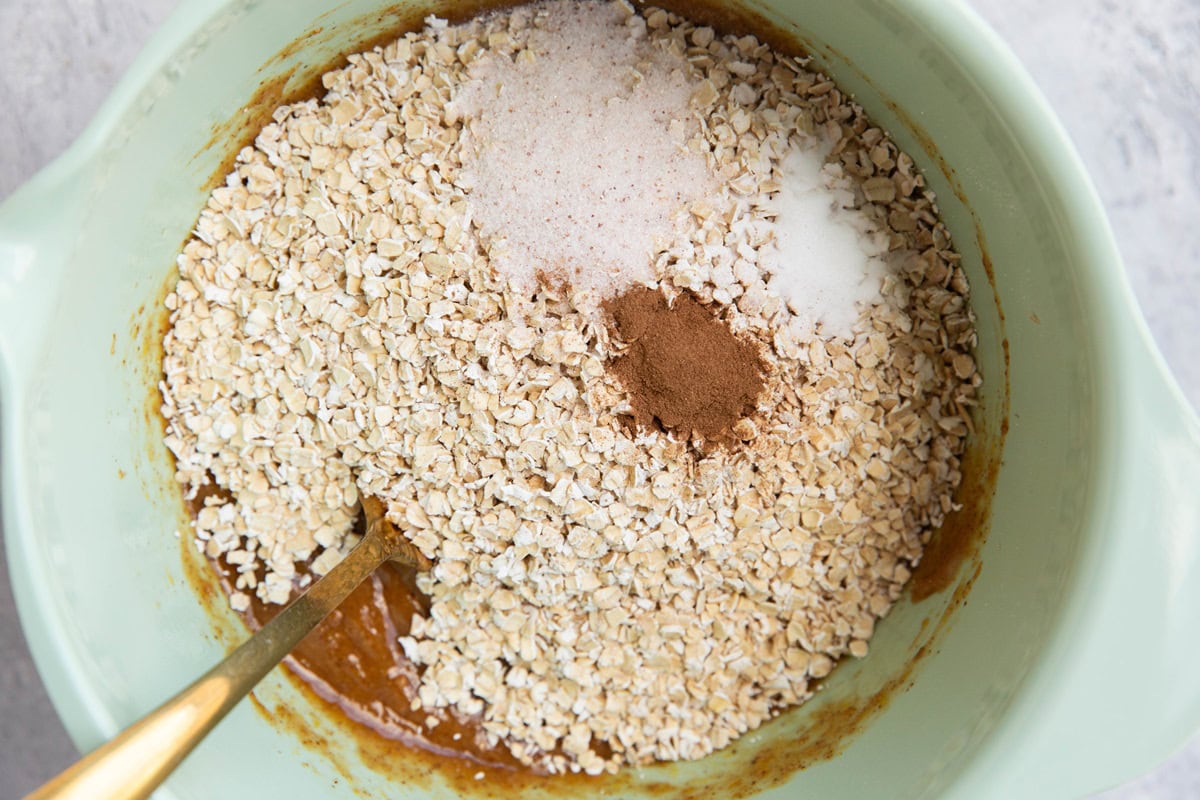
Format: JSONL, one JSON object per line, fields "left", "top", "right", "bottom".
{"left": 162, "top": 0, "right": 980, "bottom": 774}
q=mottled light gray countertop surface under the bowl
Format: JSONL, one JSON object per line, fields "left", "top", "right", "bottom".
{"left": 0, "top": 0, "right": 1200, "bottom": 800}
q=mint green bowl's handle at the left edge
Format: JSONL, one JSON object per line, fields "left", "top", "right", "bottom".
{"left": 0, "top": 156, "right": 90, "bottom": 383}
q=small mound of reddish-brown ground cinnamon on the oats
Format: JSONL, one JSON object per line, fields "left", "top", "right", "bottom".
{"left": 604, "top": 287, "right": 766, "bottom": 444}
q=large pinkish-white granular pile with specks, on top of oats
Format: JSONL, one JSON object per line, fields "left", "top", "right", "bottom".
{"left": 455, "top": 0, "right": 716, "bottom": 300}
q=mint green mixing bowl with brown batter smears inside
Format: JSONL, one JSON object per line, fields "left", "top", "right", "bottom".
{"left": 0, "top": 0, "right": 1200, "bottom": 800}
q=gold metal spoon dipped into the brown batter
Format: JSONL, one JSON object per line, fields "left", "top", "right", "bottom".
{"left": 25, "top": 497, "right": 432, "bottom": 800}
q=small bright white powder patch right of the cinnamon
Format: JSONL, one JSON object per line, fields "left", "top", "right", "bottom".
{"left": 764, "top": 137, "right": 888, "bottom": 338}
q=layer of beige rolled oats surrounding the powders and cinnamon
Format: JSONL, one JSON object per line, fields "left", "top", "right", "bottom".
{"left": 163, "top": 0, "right": 979, "bottom": 772}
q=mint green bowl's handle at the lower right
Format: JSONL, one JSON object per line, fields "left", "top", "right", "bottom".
{"left": 973, "top": 326, "right": 1200, "bottom": 798}
